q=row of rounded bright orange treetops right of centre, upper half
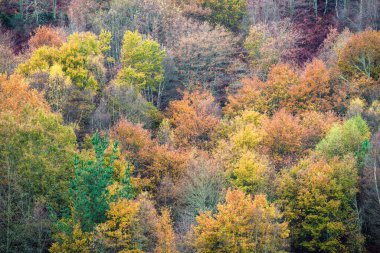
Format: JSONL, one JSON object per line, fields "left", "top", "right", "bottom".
{"left": 224, "top": 59, "right": 333, "bottom": 116}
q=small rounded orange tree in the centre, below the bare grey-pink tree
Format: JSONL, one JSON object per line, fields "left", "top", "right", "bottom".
{"left": 168, "top": 91, "right": 220, "bottom": 148}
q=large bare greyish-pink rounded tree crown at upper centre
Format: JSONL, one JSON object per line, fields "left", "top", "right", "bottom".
{"left": 168, "top": 21, "right": 246, "bottom": 101}
